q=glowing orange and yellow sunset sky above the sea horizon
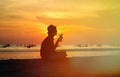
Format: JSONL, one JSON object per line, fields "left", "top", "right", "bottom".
{"left": 0, "top": 0, "right": 120, "bottom": 44}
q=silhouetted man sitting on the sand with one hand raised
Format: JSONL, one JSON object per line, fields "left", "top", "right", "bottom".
{"left": 40, "top": 25, "right": 67, "bottom": 60}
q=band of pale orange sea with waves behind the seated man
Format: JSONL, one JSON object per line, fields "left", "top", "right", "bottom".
{"left": 0, "top": 45, "right": 120, "bottom": 60}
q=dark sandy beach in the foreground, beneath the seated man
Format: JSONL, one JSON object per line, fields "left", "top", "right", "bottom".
{"left": 0, "top": 55, "right": 120, "bottom": 77}
